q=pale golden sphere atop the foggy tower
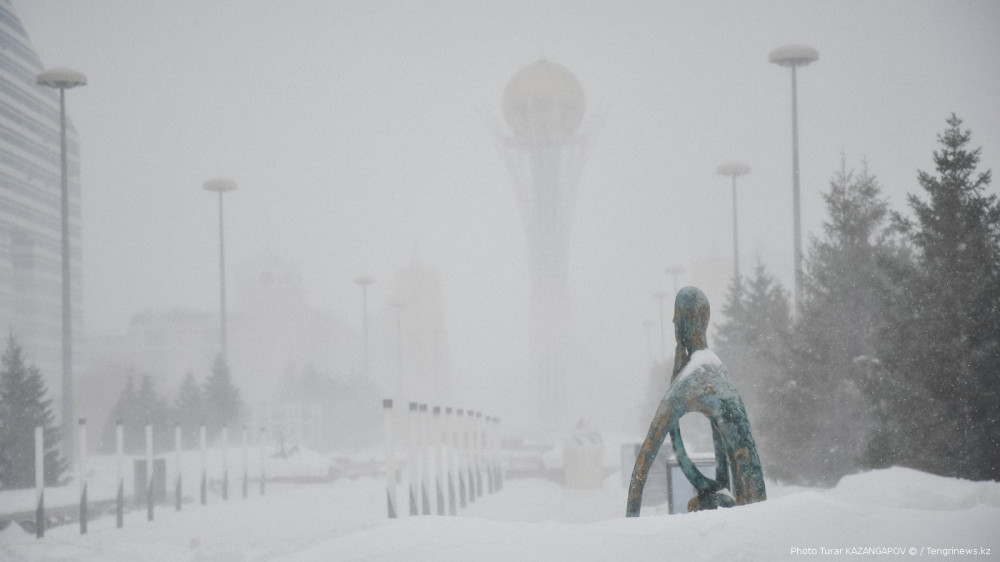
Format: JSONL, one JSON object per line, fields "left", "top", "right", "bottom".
{"left": 503, "top": 59, "right": 584, "bottom": 140}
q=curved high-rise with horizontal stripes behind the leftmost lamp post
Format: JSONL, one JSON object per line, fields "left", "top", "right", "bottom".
{"left": 0, "top": 0, "right": 82, "bottom": 394}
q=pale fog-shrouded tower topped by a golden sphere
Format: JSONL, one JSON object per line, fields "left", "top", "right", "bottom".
{"left": 501, "top": 59, "right": 585, "bottom": 430}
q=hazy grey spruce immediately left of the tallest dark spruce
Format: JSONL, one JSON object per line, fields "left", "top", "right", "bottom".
{"left": 789, "top": 156, "right": 894, "bottom": 485}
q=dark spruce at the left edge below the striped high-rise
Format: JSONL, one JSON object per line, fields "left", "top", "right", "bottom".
{"left": 0, "top": 335, "right": 66, "bottom": 489}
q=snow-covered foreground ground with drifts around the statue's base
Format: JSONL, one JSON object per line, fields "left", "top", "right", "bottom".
{"left": 0, "top": 460, "right": 1000, "bottom": 562}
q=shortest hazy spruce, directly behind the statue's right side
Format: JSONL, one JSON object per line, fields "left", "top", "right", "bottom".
{"left": 714, "top": 260, "right": 801, "bottom": 482}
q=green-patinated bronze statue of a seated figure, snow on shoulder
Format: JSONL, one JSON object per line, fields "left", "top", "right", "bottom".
{"left": 625, "top": 287, "right": 767, "bottom": 517}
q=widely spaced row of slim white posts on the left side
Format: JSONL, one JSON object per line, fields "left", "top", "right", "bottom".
{"left": 35, "top": 418, "right": 267, "bottom": 538}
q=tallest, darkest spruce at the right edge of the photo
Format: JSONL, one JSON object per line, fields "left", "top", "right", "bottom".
{"left": 882, "top": 114, "right": 1000, "bottom": 480}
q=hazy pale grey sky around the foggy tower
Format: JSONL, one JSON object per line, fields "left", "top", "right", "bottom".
{"left": 14, "top": 0, "right": 1000, "bottom": 424}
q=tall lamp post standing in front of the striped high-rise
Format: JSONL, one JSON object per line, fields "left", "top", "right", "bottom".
{"left": 35, "top": 68, "right": 87, "bottom": 459}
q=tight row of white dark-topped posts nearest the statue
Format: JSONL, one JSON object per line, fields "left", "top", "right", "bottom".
{"left": 382, "top": 398, "right": 503, "bottom": 518}
